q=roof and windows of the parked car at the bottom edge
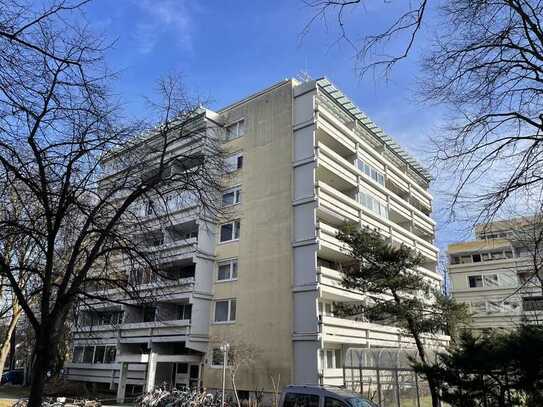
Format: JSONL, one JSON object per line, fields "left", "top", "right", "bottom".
{"left": 279, "top": 385, "right": 379, "bottom": 407}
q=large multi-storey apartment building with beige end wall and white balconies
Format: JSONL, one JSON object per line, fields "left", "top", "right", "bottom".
{"left": 66, "top": 79, "right": 443, "bottom": 400}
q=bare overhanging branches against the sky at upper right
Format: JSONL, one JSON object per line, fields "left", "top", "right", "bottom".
{"left": 309, "top": 0, "right": 543, "bottom": 221}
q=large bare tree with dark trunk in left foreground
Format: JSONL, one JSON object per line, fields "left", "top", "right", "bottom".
{"left": 0, "top": 1, "right": 222, "bottom": 406}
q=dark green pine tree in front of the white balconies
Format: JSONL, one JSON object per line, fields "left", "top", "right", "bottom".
{"left": 337, "top": 224, "right": 468, "bottom": 407}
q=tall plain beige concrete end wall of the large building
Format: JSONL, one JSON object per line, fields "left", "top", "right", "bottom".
{"left": 203, "top": 82, "right": 293, "bottom": 391}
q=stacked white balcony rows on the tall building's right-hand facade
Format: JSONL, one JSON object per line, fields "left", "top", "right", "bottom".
{"left": 315, "top": 91, "right": 447, "bottom": 384}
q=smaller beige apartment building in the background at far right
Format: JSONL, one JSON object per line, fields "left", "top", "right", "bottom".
{"left": 448, "top": 218, "right": 543, "bottom": 333}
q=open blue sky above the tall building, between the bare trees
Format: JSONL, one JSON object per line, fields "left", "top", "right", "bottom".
{"left": 86, "top": 0, "right": 465, "bottom": 247}
